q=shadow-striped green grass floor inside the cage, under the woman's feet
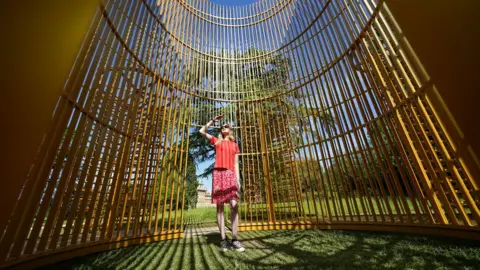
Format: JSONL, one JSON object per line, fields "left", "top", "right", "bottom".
{"left": 41, "top": 230, "right": 480, "bottom": 269}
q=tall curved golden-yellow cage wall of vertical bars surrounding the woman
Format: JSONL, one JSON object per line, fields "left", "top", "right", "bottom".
{"left": 0, "top": 0, "right": 480, "bottom": 265}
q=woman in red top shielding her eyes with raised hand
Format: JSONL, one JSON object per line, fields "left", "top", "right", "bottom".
{"left": 200, "top": 115, "right": 245, "bottom": 252}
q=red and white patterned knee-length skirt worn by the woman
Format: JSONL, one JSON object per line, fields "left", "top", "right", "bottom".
{"left": 212, "top": 169, "right": 238, "bottom": 204}
